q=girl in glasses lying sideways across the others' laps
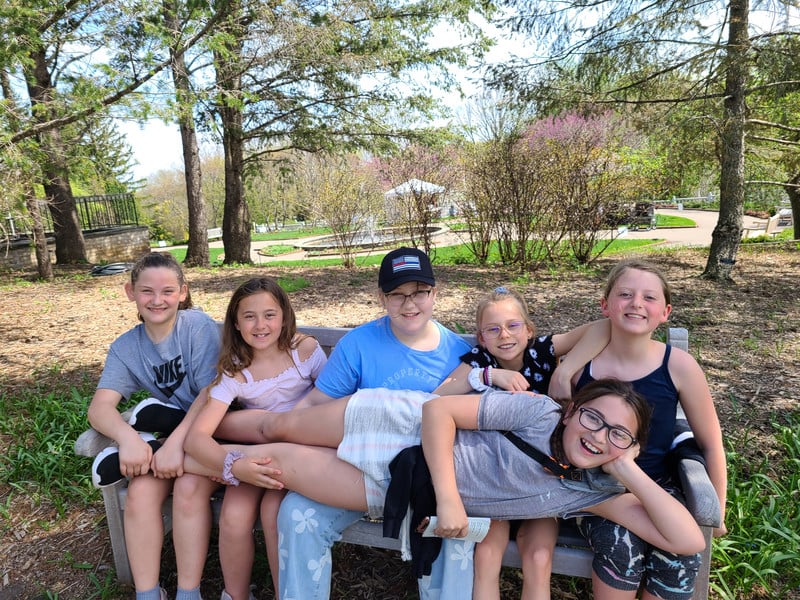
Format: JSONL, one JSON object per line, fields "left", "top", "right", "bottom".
{"left": 186, "top": 379, "right": 705, "bottom": 564}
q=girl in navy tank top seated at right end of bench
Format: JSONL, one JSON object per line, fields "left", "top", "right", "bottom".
{"left": 574, "top": 260, "right": 727, "bottom": 600}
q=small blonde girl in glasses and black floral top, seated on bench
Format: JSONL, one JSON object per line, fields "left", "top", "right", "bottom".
{"left": 434, "top": 287, "right": 610, "bottom": 600}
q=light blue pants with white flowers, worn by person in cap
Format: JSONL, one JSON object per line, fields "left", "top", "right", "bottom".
{"left": 278, "top": 492, "right": 474, "bottom": 600}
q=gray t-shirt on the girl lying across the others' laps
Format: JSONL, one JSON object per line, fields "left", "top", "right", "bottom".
{"left": 454, "top": 391, "right": 622, "bottom": 520}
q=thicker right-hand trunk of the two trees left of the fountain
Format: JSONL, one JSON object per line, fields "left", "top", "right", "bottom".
{"left": 214, "top": 1, "right": 252, "bottom": 264}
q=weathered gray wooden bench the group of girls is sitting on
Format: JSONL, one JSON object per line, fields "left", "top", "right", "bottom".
{"left": 75, "top": 327, "right": 720, "bottom": 600}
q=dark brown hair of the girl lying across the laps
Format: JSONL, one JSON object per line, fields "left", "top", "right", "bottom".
{"left": 550, "top": 377, "right": 653, "bottom": 462}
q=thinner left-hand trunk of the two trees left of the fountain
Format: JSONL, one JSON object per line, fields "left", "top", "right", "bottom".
{"left": 164, "top": 1, "right": 210, "bottom": 267}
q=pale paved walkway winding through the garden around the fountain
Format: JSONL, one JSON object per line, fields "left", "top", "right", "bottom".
{"left": 211, "top": 209, "right": 767, "bottom": 264}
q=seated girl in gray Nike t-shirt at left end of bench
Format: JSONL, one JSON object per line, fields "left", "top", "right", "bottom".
{"left": 88, "top": 252, "right": 220, "bottom": 600}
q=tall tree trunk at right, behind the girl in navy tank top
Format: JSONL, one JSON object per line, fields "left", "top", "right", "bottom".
{"left": 703, "top": 0, "right": 750, "bottom": 281}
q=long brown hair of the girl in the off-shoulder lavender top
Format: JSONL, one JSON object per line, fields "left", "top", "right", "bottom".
{"left": 216, "top": 277, "right": 306, "bottom": 381}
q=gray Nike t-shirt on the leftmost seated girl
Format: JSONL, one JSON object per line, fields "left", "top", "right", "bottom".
{"left": 97, "top": 309, "right": 220, "bottom": 411}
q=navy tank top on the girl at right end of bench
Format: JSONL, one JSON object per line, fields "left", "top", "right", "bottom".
{"left": 576, "top": 345, "right": 678, "bottom": 481}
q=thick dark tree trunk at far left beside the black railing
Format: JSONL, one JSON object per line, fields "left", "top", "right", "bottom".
{"left": 27, "top": 49, "right": 86, "bottom": 264}
